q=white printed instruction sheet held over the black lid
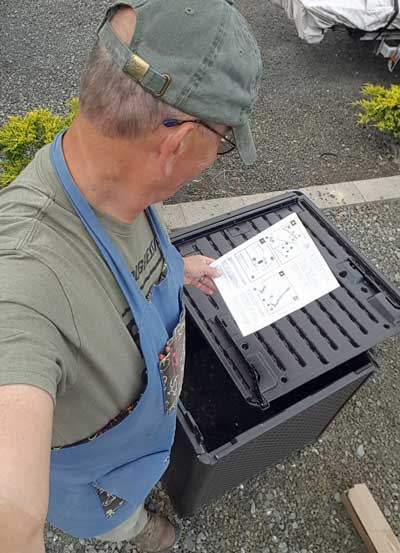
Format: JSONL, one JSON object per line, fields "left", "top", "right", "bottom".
{"left": 212, "top": 213, "right": 339, "bottom": 336}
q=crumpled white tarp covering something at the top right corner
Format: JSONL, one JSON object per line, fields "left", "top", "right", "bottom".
{"left": 271, "top": 0, "right": 400, "bottom": 44}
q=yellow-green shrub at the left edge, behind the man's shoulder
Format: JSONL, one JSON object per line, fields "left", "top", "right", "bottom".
{"left": 0, "top": 98, "right": 78, "bottom": 188}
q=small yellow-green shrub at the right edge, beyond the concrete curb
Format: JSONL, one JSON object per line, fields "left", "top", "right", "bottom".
{"left": 355, "top": 84, "right": 400, "bottom": 139}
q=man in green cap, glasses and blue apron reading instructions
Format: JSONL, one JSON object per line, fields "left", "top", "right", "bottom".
{"left": 0, "top": 0, "right": 261, "bottom": 553}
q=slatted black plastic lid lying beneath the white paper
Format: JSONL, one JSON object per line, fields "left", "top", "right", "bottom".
{"left": 172, "top": 192, "right": 400, "bottom": 409}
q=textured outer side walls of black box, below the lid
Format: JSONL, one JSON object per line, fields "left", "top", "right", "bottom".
{"left": 163, "top": 342, "right": 374, "bottom": 516}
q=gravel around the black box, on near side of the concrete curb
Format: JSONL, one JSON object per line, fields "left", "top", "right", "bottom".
{"left": 43, "top": 201, "right": 400, "bottom": 553}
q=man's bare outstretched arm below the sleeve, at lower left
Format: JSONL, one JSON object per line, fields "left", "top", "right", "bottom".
{"left": 0, "top": 384, "right": 54, "bottom": 553}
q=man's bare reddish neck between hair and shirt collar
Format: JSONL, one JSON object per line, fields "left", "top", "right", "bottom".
{"left": 63, "top": 114, "right": 154, "bottom": 223}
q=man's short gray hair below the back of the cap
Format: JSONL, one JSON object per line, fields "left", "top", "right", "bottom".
{"left": 79, "top": 41, "right": 185, "bottom": 139}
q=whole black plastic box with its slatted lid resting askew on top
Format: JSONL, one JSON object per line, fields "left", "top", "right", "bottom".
{"left": 164, "top": 193, "right": 400, "bottom": 516}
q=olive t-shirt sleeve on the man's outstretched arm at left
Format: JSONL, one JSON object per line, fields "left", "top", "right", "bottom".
{"left": 0, "top": 256, "right": 76, "bottom": 404}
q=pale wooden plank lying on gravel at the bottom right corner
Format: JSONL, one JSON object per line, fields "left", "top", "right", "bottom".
{"left": 342, "top": 484, "right": 400, "bottom": 553}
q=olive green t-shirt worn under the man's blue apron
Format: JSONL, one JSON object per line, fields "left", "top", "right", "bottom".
{"left": 0, "top": 146, "right": 164, "bottom": 447}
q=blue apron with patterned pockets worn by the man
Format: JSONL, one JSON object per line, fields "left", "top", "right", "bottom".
{"left": 48, "top": 133, "right": 184, "bottom": 538}
